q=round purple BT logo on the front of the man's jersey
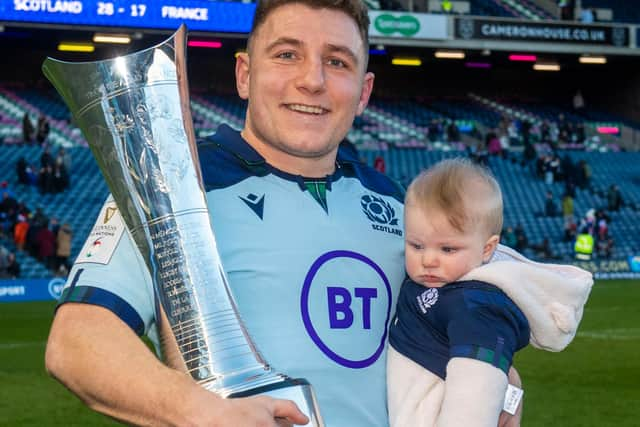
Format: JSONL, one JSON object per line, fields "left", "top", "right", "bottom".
{"left": 300, "top": 251, "right": 392, "bottom": 369}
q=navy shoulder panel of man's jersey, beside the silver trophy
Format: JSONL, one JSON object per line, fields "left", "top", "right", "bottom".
{"left": 198, "top": 125, "right": 269, "bottom": 191}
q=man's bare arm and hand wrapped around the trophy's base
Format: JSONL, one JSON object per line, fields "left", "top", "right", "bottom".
{"left": 45, "top": 303, "right": 307, "bottom": 427}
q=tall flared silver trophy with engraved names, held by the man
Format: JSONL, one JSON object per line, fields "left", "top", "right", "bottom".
{"left": 42, "top": 25, "right": 323, "bottom": 427}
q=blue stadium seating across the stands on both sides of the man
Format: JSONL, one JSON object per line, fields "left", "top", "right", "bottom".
{"left": 0, "top": 87, "right": 640, "bottom": 277}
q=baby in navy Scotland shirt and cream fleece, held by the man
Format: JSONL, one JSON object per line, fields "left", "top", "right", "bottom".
{"left": 387, "top": 159, "right": 593, "bottom": 427}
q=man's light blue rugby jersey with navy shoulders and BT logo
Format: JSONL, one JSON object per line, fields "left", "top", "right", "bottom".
{"left": 63, "top": 125, "right": 404, "bottom": 427}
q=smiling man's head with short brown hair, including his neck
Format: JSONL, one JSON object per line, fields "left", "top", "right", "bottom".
{"left": 236, "top": 4, "right": 373, "bottom": 176}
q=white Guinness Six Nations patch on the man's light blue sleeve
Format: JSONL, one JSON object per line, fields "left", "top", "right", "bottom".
{"left": 76, "top": 201, "right": 125, "bottom": 265}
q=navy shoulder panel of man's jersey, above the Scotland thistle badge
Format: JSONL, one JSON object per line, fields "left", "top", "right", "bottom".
{"left": 338, "top": 147, "right": 405, "bottom": 203}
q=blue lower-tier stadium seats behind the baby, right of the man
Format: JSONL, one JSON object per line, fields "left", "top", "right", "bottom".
{"left": 364, "top": 149, "right": 640, "bottom": 260}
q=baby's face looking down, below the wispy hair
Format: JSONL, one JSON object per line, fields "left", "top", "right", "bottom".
{"left": 404, "top": 205, "right": 498, "bottom": 288}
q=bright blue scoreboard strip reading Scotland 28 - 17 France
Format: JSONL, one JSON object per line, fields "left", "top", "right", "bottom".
{"left": 0, "top": 0, "right": 255, "bottom": 33}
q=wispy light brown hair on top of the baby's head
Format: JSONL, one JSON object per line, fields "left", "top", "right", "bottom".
{"left": 405, "top": 158, "right": 502, "bottom": 235}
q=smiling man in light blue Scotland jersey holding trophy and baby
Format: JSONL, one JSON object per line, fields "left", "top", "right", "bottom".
{"left": 46, "top": 0, "right": 404, "bottom": 427}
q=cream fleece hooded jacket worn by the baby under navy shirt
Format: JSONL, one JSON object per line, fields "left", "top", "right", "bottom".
{"left": 387, "top": 245, "right": 593, "bottom": 427}
